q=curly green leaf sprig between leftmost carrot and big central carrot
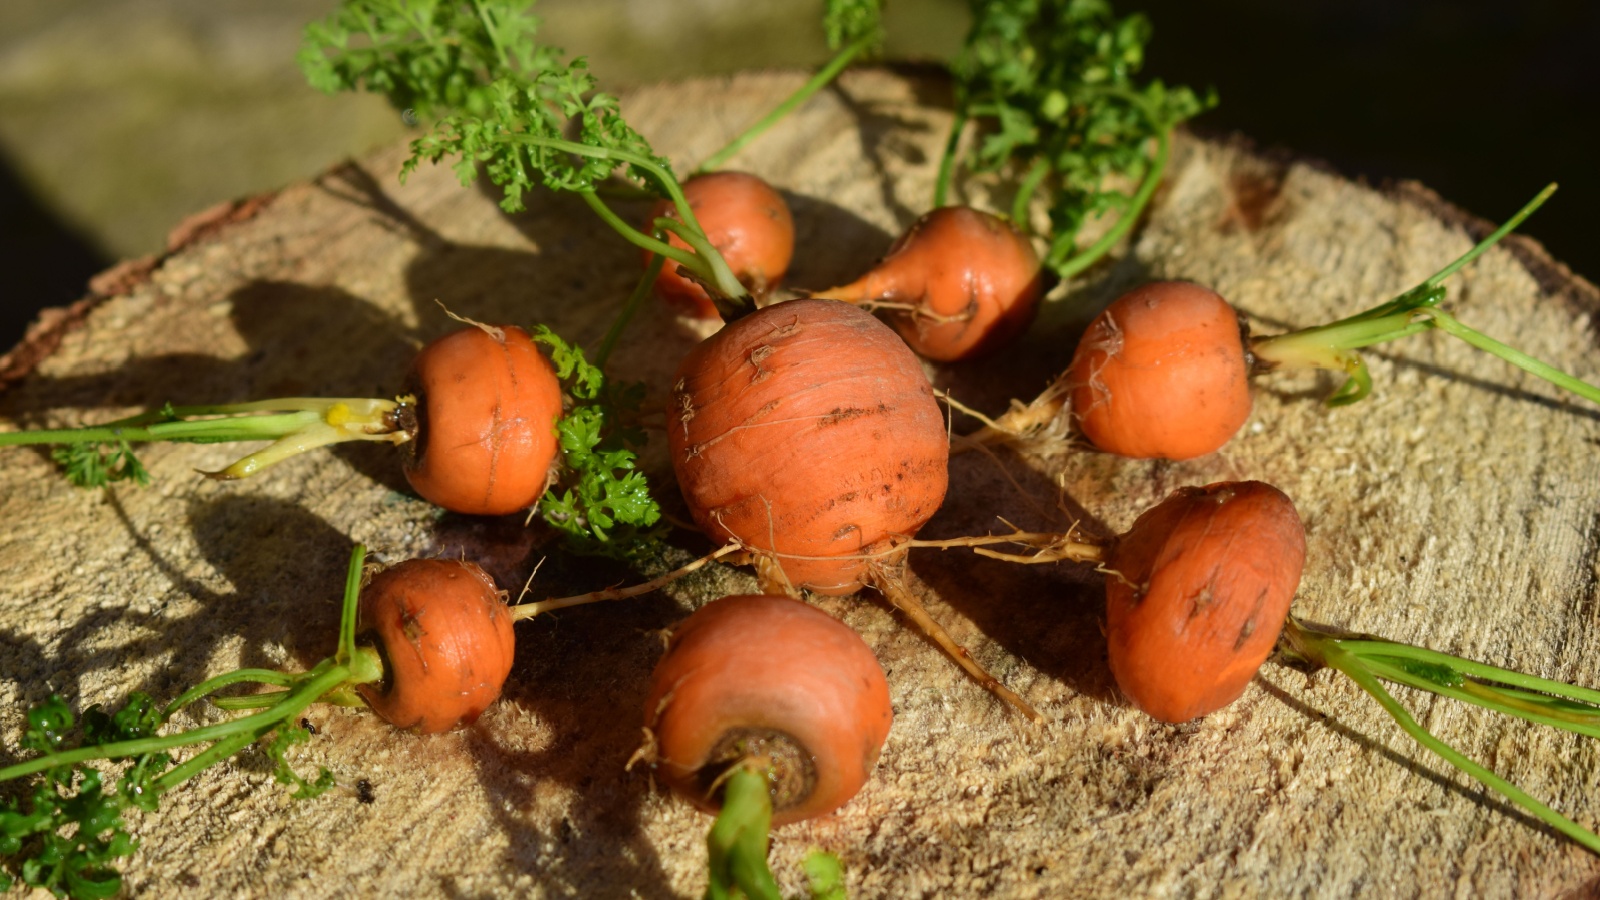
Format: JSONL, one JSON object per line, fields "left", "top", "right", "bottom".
{"left": 533, "top": 325, "right": 661, "bottom": 559}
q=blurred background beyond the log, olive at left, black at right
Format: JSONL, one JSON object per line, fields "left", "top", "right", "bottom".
{"left": 0, "top": 0, "right": 1600, "bottom": 351}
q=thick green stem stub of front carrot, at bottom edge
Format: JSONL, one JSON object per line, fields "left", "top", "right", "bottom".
{"left": 706, "top": 764, "right": 779, "bottom": 900}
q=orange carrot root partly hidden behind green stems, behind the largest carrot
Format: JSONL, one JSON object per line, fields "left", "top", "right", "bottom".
{"left": 645, "top": 171, "right": 795, "bottom": 319}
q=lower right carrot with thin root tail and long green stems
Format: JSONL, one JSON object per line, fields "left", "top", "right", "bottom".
{"left": 960, "top": 482, "right": 1600, "bottom": 854}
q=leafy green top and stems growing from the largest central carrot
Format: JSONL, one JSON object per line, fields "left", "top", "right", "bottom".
{"left": 301, "top": 0, "right": 742, "bottom": 307}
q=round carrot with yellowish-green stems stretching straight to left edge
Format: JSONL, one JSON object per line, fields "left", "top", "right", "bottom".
{"left": 0, "top": 322, "right": 562, "bottom": 516}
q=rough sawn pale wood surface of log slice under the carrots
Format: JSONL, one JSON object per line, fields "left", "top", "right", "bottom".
{"left": 0, "top": 72, "right": 1600, "bottom": 897}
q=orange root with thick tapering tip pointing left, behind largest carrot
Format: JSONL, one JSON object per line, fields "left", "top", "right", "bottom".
{"left": 818, "top": 207, "right": 1045, "bottom": 362}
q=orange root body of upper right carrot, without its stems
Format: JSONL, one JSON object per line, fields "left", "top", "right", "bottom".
{"left": 1062, "top": 282, "right": 1250, "bottom": 460}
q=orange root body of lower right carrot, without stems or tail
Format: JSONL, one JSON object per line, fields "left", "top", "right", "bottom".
{"left": 1106, "top": 482, "right": 1306, "bottom": 722}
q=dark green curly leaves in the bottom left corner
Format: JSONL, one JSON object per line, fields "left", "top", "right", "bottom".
{"left": 0, "top": 693, "right": 171, "bottom": 898}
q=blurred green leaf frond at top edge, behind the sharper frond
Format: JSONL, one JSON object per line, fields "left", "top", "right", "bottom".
{"left": 298, "top": 0, "right": 560, "bottom": 119}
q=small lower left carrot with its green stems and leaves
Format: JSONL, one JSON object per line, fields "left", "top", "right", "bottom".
{"left": 0, "top": 546, "right": 512, "bottom": 897}
